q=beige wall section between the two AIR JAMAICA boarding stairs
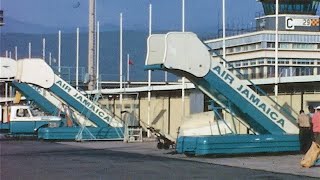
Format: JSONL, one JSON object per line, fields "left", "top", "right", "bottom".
{"left": 99, "top": 90, "right": 191, "bottom": 137}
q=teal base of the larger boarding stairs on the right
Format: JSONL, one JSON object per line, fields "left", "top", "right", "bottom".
{"left": 176, "top": 134, "right": 300, "bottom": 155}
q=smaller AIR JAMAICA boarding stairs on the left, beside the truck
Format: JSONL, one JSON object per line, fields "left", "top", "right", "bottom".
{"left": 0, "top": 58, "right": 124, "bottom": 140}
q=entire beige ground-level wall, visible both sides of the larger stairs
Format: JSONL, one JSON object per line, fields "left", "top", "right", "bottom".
{"left": 100, "top": 90, "right": 320, "bottom": 137}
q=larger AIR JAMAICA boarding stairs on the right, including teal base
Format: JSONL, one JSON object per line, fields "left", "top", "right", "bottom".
{"left": 145, "top": 32, "right": 300, "bottom": 155}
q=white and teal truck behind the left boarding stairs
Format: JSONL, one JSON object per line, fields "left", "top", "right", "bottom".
{"left": 0, "top": 105, "right": 61, "bottom": 134}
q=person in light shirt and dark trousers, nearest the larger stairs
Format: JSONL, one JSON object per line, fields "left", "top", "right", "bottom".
{"left": 297, "top": 110, "right": 312, "bottom": 154}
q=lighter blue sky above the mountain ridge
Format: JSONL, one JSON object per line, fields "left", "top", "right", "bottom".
{"left": 0, "top": 0, "right": 262, "bottom": 31}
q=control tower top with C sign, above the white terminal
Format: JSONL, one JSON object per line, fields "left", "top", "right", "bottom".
{"left": 256, "top": 0, "right": 320, "bottom": 32}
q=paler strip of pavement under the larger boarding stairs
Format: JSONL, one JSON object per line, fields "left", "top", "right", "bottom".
{"left": 58, "top": 141, "right": 320, "bottom": 178}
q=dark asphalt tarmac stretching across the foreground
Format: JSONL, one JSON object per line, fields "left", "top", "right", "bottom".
{"left": 0, "top": 139, "right": 319, "bottom": 180}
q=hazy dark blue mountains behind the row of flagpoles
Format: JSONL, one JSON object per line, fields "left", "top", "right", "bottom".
{"left": 0, "top": 18, "right": 219, "bottom": 81}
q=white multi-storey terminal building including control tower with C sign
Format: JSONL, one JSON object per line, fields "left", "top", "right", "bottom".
{"left": 206, "top": 0, "right": 320, "bottom": 103}
